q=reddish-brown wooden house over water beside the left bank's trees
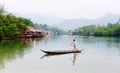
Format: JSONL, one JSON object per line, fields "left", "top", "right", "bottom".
{"left": 20, "top": 26, "right": 47, "bottom": 38}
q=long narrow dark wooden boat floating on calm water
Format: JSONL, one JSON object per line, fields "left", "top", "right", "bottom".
{"left": 41, "top": 50, "right": 81, "bottom": 54}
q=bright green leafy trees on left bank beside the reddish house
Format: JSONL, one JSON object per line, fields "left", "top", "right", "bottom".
{"left": 0, "top": 13, "right": 33, "bottom": 39}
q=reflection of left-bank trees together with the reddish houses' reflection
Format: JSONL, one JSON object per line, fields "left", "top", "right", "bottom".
{"left": 0, "top": 39, "right": 42, "bottom": 69}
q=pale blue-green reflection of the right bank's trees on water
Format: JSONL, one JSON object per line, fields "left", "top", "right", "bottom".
{"left": 77, "top": 36, "right": 120, "bottom": 48}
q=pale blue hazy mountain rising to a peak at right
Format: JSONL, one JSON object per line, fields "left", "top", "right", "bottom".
{"left": 56, "top": 13, "right": 120, "bottom": 30}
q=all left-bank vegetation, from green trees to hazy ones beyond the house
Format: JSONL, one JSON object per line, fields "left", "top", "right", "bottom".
{"left": 0, "top": 4, "right": 63, "bottom": 39}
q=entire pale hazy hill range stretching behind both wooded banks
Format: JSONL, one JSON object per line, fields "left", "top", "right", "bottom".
{"left": 14, "top": 13, "right": 120, "bottom": 30}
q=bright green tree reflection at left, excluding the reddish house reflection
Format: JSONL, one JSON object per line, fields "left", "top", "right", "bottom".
{"left": 0, "top": 40, "right": 29, "bottom": 69}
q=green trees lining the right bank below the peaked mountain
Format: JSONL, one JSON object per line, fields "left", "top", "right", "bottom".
{"left": 73, "top": 22, "right": 120, "bottom": 36}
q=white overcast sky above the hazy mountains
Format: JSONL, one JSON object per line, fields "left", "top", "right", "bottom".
{"left": 0, "top": 0, "right": 120, "bottom": 19}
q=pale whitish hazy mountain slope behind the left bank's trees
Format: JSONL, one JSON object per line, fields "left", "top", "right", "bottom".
{"left": 13, "top": 13, "right": 64, "bottom": 25}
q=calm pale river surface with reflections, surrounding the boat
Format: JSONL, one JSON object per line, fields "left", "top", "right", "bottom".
{"left": 0, "top": 35, "right": 120, "bottom": 73}
